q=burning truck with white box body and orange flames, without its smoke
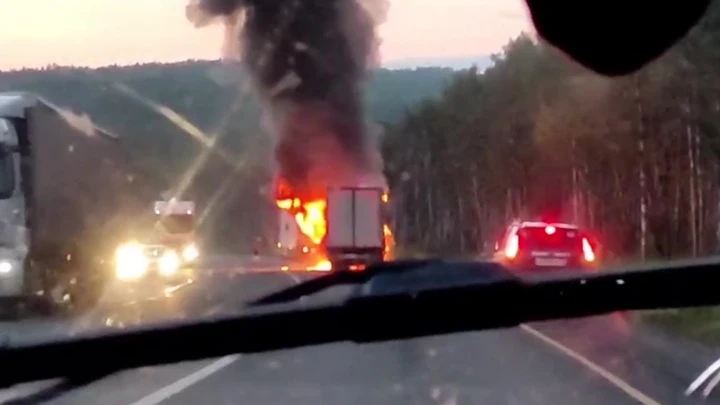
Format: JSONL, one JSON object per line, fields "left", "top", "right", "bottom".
{"left": 277, "top": 178, "right": 394, "bottom": 271}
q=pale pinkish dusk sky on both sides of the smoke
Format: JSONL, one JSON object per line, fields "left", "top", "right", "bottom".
{"left": 0, "top": 0, "right": 531, "bottom": 70}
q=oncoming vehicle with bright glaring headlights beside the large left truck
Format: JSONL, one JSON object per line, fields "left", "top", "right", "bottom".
{"left": 115, "top": 198, "right": 200, "bottom": 285}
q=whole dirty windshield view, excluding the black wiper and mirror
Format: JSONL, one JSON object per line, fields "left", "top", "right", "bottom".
{"left": 0, "top": 0, "right": 720, "bottom": 405}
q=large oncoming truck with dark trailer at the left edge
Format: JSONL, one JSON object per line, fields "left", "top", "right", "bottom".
{"left": 0, "top": 92, "right": 142, "bottom": 312}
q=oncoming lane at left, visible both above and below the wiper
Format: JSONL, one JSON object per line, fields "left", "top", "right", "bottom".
{"left": 0, "top": 252, "right": 315, "bottom": 404}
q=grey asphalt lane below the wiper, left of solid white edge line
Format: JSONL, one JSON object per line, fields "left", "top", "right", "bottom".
{"left": 14, "top": 318, "right": 699, "bottom": 405}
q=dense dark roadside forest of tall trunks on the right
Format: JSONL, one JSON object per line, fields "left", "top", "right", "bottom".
{"left": 384, "top": 21, "right": 720, "bottom": 259}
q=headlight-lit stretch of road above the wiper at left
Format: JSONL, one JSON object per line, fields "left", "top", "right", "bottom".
{"left": 0, "top": 255, "right": 303, "bottom": 342}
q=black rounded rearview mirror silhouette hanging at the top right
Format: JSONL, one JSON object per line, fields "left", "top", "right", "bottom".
{"left": 525, "top": 0, "right": 711, "bottom": 76}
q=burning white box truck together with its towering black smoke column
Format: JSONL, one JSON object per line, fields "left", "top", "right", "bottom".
{"left": 185, "top": 0, "right": 393, "bottom": 270}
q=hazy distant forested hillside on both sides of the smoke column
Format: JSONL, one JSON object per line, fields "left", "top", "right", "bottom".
{"left": 0, "top": 61, "right": 454, "bottom": 251}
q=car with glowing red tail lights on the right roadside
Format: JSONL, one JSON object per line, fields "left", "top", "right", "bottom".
{"left": 493, "top": 221, "right": 598, "bottom": 271}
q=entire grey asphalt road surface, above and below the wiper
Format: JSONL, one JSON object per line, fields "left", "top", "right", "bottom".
{"left": 0, "top": 257, "right": 720, "bottom": 405}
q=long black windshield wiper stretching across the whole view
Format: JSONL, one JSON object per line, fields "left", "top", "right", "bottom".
{"left": 0, "top": 260, "right": 720, "bottom": 386}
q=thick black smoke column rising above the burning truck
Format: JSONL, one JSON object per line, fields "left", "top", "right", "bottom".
{"left": 187, "top": 0, "right": 388, "bottom": 199}
